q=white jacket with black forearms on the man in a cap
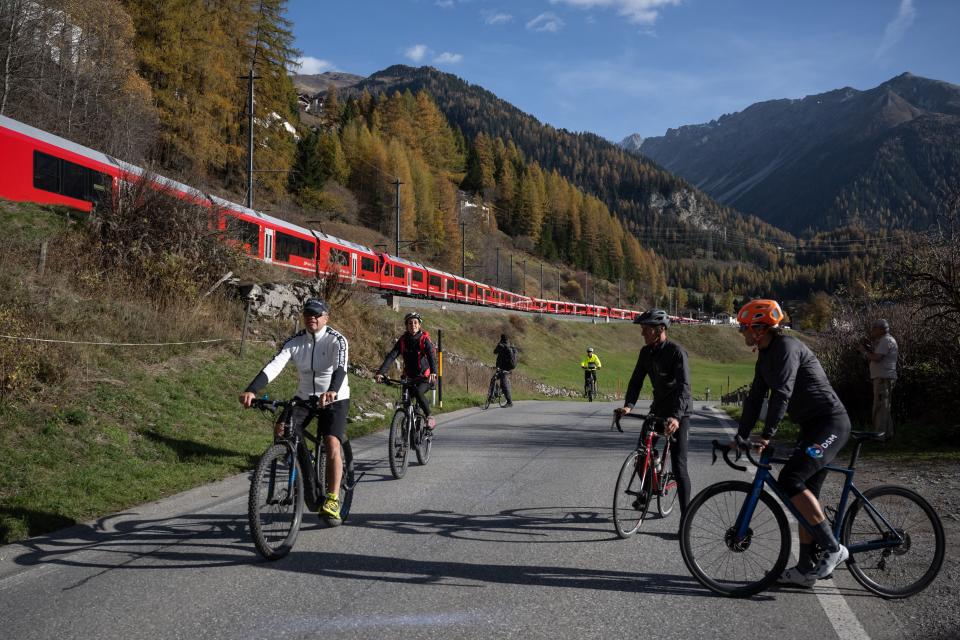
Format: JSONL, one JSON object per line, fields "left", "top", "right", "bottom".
{"left": 247, "top": 326, "right": 350, "bottom": 401}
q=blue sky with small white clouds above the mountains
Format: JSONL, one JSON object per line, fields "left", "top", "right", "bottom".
{"left": 288, "top": 0, "right": 960, "bottom": 141}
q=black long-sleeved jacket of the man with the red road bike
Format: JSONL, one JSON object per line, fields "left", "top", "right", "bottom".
{"left": 623, "top": 340, "right": 692, "bottom": 420}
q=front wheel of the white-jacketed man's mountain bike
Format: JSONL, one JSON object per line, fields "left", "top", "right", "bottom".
{"left": 247, "top": 444, "right": 303, "bottom": 560}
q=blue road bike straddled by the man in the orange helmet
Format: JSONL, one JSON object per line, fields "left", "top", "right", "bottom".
{"left": 680, "top": 431, "right": 946, "bottom": 598}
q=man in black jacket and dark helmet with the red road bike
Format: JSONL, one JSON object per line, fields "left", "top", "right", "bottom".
{"left": 617, "top": 309, "right": 693, "bottom": 514}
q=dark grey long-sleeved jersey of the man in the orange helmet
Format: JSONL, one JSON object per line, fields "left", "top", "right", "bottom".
{"left": 738, "top": 335, "right": 846, "bottom": 440}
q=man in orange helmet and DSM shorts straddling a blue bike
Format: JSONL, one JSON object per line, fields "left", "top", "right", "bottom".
{"left": 734, "top": 300, "right": 850, "bottom": 587}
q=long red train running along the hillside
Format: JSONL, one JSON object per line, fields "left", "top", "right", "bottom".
{"left": 0, "top": 116, "right": 652, "bottom": 320}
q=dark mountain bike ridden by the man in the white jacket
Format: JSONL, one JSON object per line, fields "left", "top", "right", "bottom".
{"left": 247, "top": 398, "right": 363, "bottom": 560}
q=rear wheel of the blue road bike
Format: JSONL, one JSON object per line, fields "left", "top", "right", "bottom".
{"left": 840, "top": 485, "right": 946, "bottom": 598}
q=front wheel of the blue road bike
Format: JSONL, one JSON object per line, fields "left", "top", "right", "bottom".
{"left": 680, "top": 480, "right": 790, "bottom": 596}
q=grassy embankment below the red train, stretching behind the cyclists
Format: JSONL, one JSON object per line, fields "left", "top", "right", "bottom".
{"left": 0, "top": 203, "right": 751, "bottom": 543}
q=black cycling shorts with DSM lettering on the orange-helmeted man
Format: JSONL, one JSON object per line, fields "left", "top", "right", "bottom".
{"left": 777, "top": 413, "right": 850, "bottom": 498}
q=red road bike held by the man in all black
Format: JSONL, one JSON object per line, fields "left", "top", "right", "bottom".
{"left": 613, "top": 412, "right": 677, "bottom": 539}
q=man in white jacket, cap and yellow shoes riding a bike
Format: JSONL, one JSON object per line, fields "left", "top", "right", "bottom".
{"left": 240, "top": 298, "right": 350, "bottom": 524}
